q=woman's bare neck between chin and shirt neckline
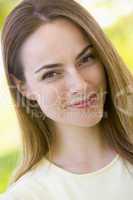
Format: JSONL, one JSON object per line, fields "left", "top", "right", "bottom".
{"left": 45, "top": 118, "right": 112, "bottom": 165}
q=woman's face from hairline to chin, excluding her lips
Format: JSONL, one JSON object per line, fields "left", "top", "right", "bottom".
{"left": 20, "top": 19, "right": 106, "bottom": 126}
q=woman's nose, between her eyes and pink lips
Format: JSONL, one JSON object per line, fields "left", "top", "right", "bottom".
{"left": 68, "top": 68, "right": 88, "bottom": 95}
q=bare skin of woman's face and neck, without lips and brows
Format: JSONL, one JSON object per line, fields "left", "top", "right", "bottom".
{"left": 12, "top": 19, "right": 115, "bottom": 172}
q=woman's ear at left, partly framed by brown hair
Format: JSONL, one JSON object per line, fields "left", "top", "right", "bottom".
{"left": 9, "top": 73, "right": 36, "bottom": 100}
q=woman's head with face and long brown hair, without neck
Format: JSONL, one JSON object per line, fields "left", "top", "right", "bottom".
{"left": 2, "top": 0, "right": 133, "bottom": 182}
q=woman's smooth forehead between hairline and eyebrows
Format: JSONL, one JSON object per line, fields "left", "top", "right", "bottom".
{"left": 20, "top": 19, "right": 89, "bottom": 70}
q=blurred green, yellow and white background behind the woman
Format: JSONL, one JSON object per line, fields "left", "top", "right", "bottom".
{"left": 0, "top": 0, "right": 133, "bottom": 193}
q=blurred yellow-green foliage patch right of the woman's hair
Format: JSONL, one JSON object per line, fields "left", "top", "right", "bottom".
{"left": 105, "top": 13, "right": 133, "bottom": 71}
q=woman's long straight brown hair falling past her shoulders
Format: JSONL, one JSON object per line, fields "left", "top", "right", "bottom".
{"left": 2, "top": 0, "right": 133, "bottom": 182}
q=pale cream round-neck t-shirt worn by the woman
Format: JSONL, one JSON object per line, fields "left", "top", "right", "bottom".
{"left": 0, "top": 154, "right": 133, "bottom": 200}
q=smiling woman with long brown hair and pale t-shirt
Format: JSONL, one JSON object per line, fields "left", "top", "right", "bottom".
{"left": 2, "top": 0, "right": 133, "bottom": 200}
